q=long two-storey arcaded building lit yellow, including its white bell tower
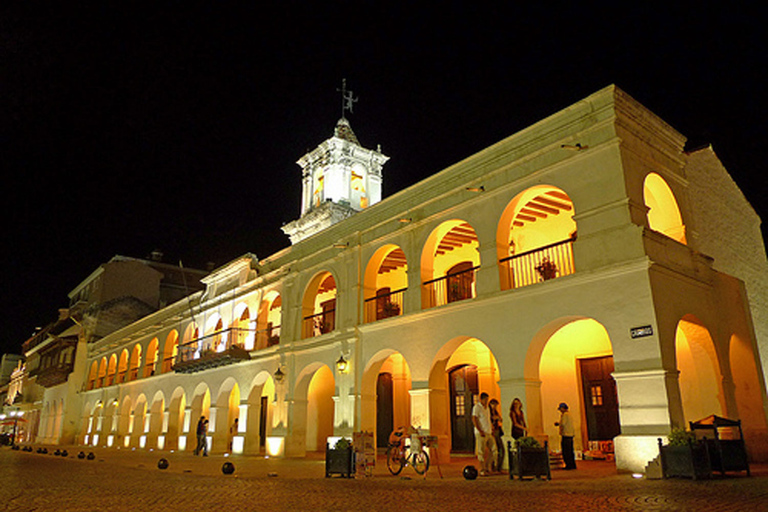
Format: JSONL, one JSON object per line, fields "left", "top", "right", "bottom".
{"left": 24, "top": 86, "right": 768, "bottom": 471}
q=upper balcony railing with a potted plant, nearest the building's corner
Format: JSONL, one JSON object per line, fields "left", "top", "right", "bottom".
{"left": 499, "top": 237, "right": 576, "bottom": 288}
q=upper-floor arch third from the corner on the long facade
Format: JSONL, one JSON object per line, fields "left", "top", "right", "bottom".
{"left": 363, "top": 244, "right": 408, "bottom": 322}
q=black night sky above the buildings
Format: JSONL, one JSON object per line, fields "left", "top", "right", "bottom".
{"left": 0, "top": 4, "right": 768, "bottom": 352}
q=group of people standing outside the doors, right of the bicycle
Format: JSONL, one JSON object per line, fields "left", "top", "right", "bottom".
{"left": 472, "top": 392, "right": 576, "bottom": 476}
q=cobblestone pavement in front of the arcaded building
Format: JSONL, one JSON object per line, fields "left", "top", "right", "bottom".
{"left": 0, "top": 447, "right": 768, "bottom": 512}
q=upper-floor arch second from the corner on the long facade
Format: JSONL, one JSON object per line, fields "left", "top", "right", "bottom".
{"left": 421, "top": 219, "right": 480, "bottom": 309}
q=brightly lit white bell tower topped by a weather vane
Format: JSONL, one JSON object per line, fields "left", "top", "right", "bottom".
{"left": 283, "top": 84, "right": 389, "bottom": 244}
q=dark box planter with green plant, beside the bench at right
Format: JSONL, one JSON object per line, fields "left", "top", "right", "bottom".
{"left": 658, "top": 428, "right": 712, "bottom": 480}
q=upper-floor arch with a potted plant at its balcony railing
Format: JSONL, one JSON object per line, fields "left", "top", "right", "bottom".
{"left": 496, "top": 185, "right": 577, "bottom": 290}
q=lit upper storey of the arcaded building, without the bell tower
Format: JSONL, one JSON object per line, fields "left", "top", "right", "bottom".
{"left": 88, "top": 87, "right": 732, "bottom": 387}
